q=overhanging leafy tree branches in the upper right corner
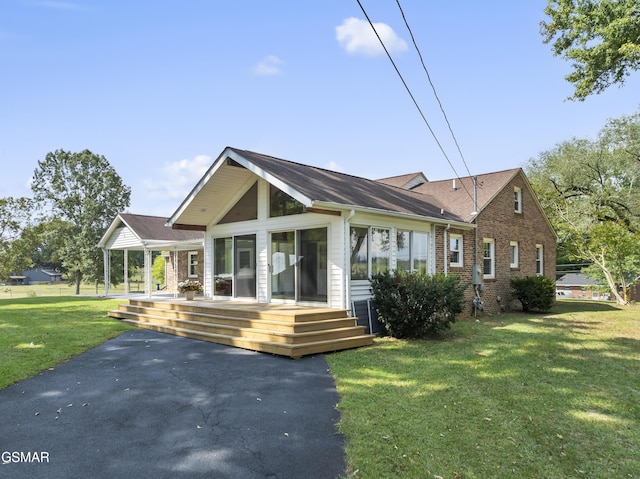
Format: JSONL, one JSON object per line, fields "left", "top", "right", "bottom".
{"left": 540, "top": 0, "right": 640, "bottom": 101}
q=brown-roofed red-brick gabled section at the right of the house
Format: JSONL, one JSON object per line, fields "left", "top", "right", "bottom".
{"left": 383, "top": 168, "right": 557, "bottom": 313}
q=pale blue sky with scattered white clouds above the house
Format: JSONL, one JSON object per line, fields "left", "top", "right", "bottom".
{"left": 0, "top": 0, "right": 640, "bottom": 217}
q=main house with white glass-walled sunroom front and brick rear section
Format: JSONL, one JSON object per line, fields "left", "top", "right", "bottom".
{"left": 167, "top": 147, "right": 556, "bottom": 313}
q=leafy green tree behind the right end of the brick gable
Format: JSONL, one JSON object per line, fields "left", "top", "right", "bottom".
{"left": 527, "top": 112, "right": 640, "bottom": 304}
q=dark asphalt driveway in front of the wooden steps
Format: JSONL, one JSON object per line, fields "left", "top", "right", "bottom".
{"left": 0, "top": 330, "right": 346, "bottom": 479}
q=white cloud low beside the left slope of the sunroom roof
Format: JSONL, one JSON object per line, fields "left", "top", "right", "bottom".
{"left": 142, "top": 155, "right": 212, "bottom": 203}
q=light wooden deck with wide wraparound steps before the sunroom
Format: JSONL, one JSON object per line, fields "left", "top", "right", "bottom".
{"left": 109, "top": 299, "right": 373, "bottom": 358}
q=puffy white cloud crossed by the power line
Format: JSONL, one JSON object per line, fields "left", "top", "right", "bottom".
{"left": 336, "top": 17, "right": 407, "bottom": 56}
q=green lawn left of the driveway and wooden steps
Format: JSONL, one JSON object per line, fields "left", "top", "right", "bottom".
{"left": 0, "top": 296, "right": 131, "bottom": 389}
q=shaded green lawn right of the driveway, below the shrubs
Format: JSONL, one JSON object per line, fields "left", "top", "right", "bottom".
{"left": 326, "top": 301, "right": 640, "bottom": 479}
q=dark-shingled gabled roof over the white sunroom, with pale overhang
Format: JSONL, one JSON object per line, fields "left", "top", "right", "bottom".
{"left": 167, "top": 147, "right": 469, "bottom": 229}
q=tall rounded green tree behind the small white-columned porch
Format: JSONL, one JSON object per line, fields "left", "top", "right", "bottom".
{"left": 31, "top": 150, "right": 131, "bottom": 294}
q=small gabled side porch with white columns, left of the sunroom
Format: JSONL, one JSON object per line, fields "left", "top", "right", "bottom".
{"left": 98, "top": 213, "right": 204, "bottom": 295}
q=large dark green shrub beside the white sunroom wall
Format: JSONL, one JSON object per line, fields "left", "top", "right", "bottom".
{"left": 371, "top": 271, "right": 465, "bottom": 339}
